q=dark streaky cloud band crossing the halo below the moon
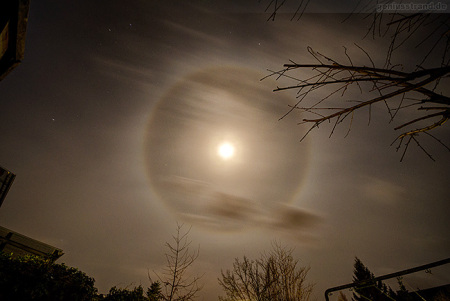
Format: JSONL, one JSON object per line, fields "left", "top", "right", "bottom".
{"left": 156, "top": 176, "right": 322, "bottom": 237}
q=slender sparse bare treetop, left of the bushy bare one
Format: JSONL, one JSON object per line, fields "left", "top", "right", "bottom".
{"left": 149, "top": 224, "right": 202, "bottom": 301}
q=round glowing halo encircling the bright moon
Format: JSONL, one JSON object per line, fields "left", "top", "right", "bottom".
{"left": 144, "top": 66, "right": 309, "bottom": 230}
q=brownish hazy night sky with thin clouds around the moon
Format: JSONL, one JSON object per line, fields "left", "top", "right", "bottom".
{"left": 0, "top": 0, "right": 450, "bottom": 300}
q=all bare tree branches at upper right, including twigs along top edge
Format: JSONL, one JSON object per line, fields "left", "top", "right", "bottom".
{"left": 266, "top": 0, "right": 450, "bottom": 160}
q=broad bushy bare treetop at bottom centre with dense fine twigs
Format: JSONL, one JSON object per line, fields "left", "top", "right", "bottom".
{"left": 218, "top": 244, "right": 313, "bottom": 301}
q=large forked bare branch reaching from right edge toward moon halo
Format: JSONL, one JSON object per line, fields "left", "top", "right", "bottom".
{"left": 264, "top": 46, "right": 450, "bottom": 158}
